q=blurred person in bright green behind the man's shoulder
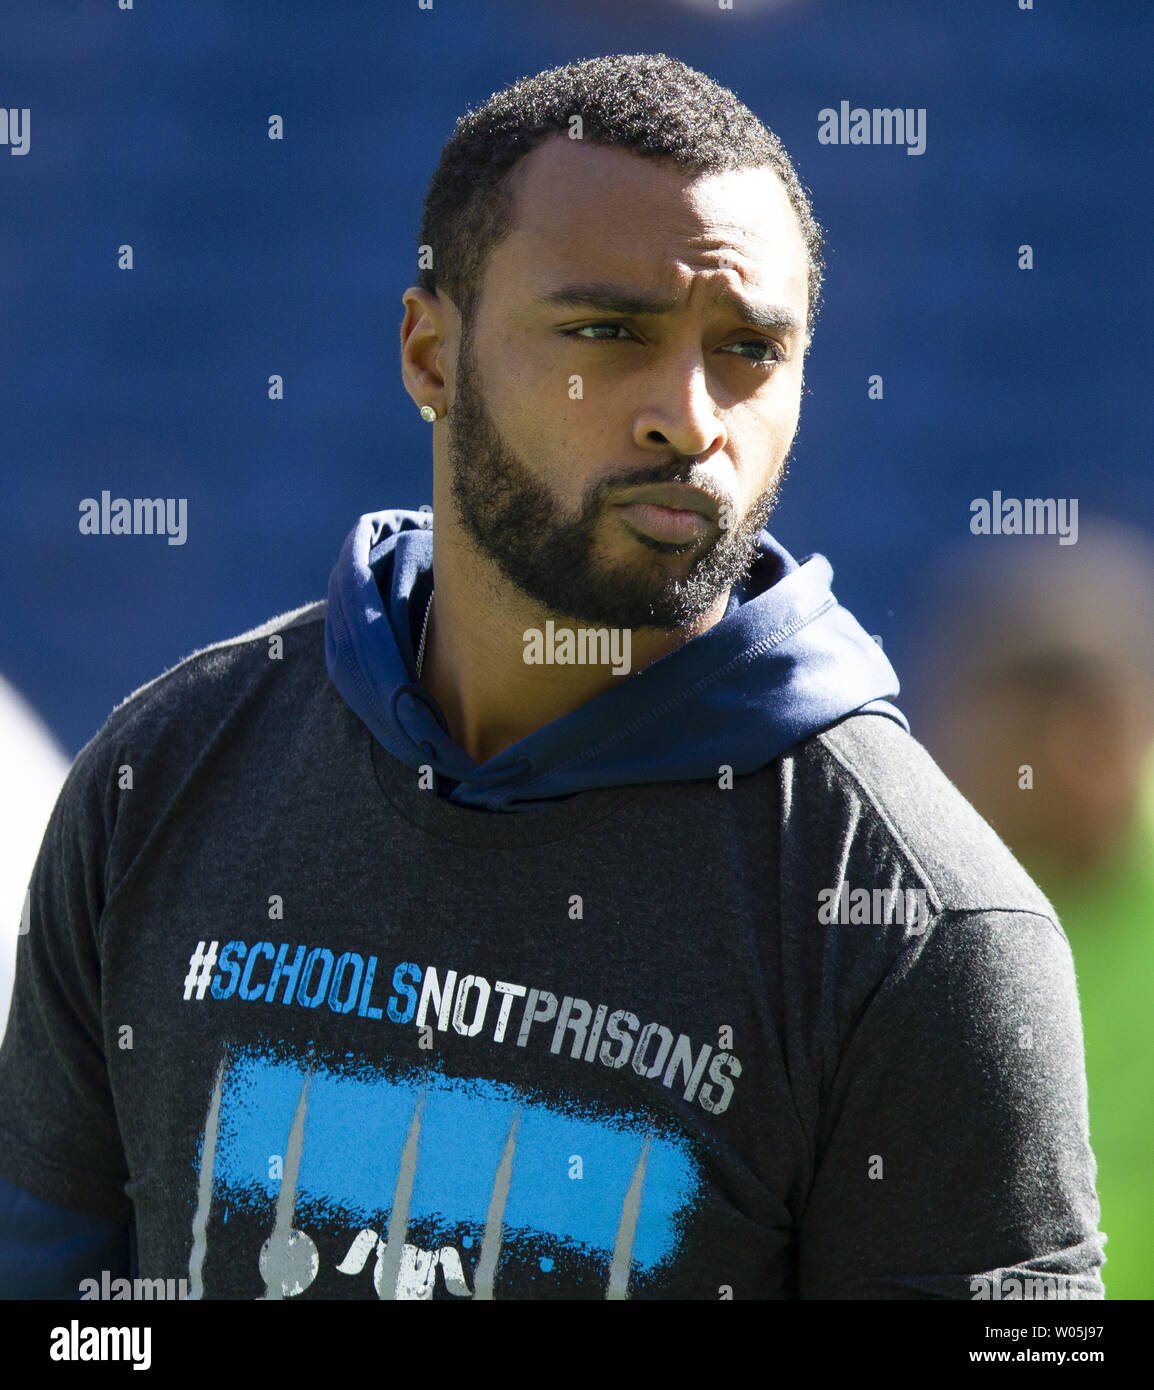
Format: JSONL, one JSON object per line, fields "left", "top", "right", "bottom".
{"left": 911, "top": 521, "right": 1154, "bottom": 1298}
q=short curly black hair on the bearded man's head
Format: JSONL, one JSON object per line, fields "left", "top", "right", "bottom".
{"left": 417, "top": 53, "right": 824, "bottom": 332}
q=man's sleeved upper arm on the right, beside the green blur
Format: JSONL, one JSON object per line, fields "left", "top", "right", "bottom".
{"left": 799, "top": 912, "right": 1104, "bottom": 1298}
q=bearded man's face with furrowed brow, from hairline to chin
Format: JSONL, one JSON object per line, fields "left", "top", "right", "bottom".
{"left": 446, "top": 136, "right": 808, "bottom": 630}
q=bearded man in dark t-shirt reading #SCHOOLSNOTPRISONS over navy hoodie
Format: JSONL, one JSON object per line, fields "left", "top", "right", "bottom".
{"left": 0, "top": 56, "right": 1103, "bottom": 1300}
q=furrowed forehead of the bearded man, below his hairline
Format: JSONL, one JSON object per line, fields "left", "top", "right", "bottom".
{"left": 491, "top": 136, "right": 809, "bottom": 313}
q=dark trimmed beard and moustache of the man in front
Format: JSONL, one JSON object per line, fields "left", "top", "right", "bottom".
{"left": 446, "top": 311, "right": 788, "bottom": 631}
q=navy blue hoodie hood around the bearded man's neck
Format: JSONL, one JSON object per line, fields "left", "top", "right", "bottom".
{"left": 324, "top": 510, "right": 909, "bottom": 810}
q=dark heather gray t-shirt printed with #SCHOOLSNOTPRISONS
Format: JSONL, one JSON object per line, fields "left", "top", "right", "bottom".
{"left": 0, "top": 603, "right": 1104, "bottom": 1300}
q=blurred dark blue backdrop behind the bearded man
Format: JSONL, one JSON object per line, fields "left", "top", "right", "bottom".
{"left": 0, "top": 0, "right": 1154, "bottom": 756}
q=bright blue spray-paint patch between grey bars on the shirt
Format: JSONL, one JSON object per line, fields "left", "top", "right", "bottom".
{"left": 214, "top": 1052, "right": 701, "bottom": 1272}
